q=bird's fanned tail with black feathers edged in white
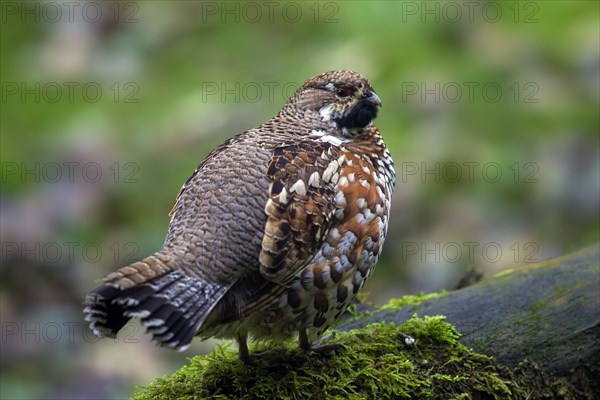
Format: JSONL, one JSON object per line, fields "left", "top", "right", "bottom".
{"left": 84, "top": 256, "right": 230, "bottom": 351}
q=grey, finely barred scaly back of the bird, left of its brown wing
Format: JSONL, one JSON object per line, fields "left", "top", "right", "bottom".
{"left": 164, "top": 131, "right": 272, "bottom": 284}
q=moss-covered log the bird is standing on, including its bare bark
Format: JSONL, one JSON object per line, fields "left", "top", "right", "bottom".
{"left": 134, "top": 246, "right": 600, "bottom": 400}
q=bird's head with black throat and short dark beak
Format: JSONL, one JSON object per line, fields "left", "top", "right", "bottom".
{"left": 290, "top": 70, "right": 381, "bottom": 136}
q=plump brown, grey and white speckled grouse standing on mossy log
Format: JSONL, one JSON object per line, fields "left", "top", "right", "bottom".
{"left": 84, "top": 70, "right": 395, "bottom": 360}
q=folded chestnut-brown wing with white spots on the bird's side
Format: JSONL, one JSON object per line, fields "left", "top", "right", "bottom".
{"left": 260, "top": 140, "right": 340, "bottom": 285}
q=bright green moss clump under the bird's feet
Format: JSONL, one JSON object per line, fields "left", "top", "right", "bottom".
{"left": 134, "top": 316, "right": 525, "bottom": 400}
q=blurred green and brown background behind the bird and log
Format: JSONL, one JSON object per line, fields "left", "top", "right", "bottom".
{"left": 0, "top": 1, "right": 600, "bottom": 399}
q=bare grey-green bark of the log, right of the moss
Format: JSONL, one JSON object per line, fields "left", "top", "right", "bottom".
{"left": 337, "top": 245, "right": 600, "bottom": 376}
